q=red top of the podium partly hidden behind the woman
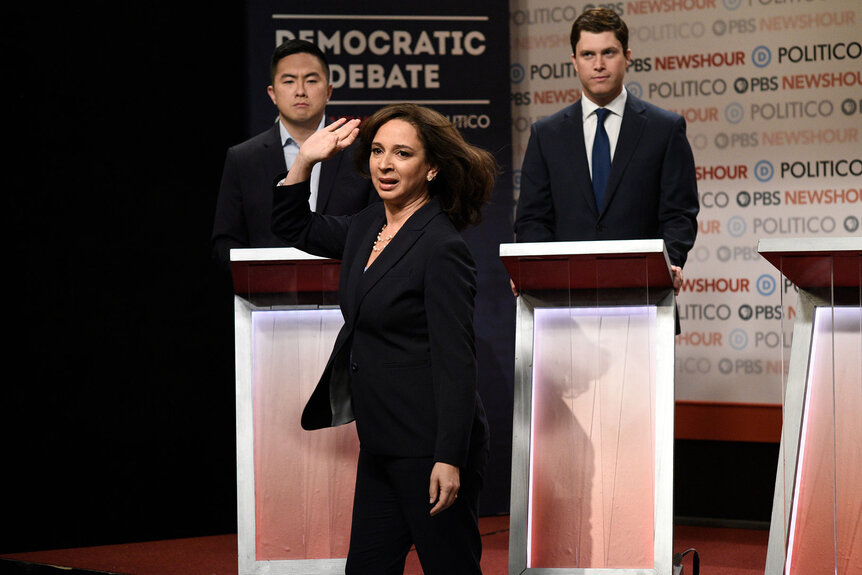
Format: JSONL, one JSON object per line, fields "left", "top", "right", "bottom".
{"left": 230, "top": 248, "right": 341, "bottom": 296}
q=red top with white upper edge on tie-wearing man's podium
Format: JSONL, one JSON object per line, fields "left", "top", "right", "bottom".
{"left": 500, "top": 240, "right": 673, "bottom": 290}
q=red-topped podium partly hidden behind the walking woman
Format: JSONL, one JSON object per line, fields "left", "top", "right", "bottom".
{"left": 231, "top": 248, "right": 359, "bottom": 575}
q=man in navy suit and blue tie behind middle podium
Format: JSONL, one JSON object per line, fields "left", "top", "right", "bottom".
{"left": 515, "top": 8, "right": 699, "bottom": 293}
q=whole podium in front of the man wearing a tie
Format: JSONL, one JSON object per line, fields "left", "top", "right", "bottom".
{"left": 500, "top": 240, "right": 675, "bottom": 575}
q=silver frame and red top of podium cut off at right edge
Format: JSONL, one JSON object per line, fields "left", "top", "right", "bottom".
{"left": 757, "top": 238, "right": 862, "bottom": 575}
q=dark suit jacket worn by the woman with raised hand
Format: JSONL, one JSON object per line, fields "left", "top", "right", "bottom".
{"left": 273, "top": 182, "right": 488, "bottom": 473}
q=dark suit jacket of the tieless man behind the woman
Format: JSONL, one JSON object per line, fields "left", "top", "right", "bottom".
{"left": 212, "top": 123, "right": 379, "bottom": 268}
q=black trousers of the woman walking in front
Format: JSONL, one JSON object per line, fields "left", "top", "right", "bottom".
{"left": 345, "top": 449, "right": 482, "bottom": 575}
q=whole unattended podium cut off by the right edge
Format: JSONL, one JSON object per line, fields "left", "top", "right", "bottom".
{"left": 757, "top": 238, "right": 862, "bottom": 575}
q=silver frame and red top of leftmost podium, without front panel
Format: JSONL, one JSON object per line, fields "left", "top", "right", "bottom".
{"left": 231, "top": 248, "right": 349, "bottom": 575}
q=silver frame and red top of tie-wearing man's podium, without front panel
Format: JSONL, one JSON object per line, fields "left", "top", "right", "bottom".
{"left": 500, "top": 240, "right": 675, "bottom": 575}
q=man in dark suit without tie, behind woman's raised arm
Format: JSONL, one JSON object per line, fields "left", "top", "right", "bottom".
{"left": 212, "top": 40, "right": 378, "bottom": 267}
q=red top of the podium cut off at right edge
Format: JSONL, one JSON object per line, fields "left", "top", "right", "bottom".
{"left": 757, "top": 238, "right": 862, "bottom": 288}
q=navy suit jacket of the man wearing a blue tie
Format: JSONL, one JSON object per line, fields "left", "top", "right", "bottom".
{"left": 515, "top": 94, "right": 699, "bottom": 266}
